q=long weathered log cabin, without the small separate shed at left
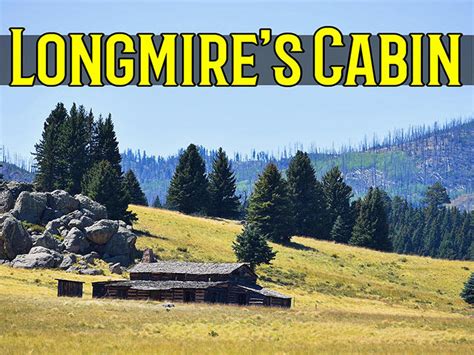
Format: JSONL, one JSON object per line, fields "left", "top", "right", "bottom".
{"left": 92, "top": 261, "right": 291, "bottom": 307}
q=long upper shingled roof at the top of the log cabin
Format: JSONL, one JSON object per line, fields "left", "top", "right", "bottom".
{"left": 128, "top": 261, "right": 254, "bottom": 275}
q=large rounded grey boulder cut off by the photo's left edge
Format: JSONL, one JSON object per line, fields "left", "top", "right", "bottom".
{"left": 0, "top": 214, "right": 33, "bottom": 260}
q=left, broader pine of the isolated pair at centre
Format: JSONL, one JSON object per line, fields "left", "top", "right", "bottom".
{"left": 166, "top": 144, "right": 208, "bottom": 213}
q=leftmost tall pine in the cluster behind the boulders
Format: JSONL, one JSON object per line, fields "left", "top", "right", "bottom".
{"left": 33, "top": 103, "right": 68, "bottom": 191}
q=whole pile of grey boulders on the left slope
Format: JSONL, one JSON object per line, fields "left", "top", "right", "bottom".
{"left": 0, "top": 183, "right": 138, "bottom": 275}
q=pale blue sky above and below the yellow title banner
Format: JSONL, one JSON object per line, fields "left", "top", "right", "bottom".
{"left": 0, "top": 0, "right": 474, "bottom": 156}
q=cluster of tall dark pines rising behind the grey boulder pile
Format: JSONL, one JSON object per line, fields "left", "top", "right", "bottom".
{"left": 33, "top": 103, "right": 147, "bottom": 223}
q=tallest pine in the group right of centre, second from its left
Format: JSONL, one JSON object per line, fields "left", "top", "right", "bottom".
{"left": 286, "top": 151, "right": 326, "bottom": 237}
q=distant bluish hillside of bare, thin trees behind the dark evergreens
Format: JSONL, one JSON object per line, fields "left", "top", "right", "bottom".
{"left": 122, "top": 119, "right": 474, "bottom": 206}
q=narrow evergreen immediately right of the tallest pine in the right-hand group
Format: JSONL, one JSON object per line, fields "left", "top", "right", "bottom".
{"left": 322, "top": 167, "right": 352, "bottom": 241}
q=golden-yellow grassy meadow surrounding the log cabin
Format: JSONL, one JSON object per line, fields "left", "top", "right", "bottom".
{"left": 0, "top": 206, "right": 474, "bottom": 354}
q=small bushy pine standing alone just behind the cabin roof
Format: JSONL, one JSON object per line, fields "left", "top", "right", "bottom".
{"left": 232, "top": 225, "right": 276, "bottom": 269}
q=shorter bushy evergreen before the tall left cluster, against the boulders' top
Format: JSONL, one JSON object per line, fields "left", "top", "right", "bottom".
{"left": 82, "top": 160, "right": 136, "bottom": 223}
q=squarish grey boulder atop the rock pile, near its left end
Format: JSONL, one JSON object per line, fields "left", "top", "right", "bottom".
{"left": 12, "top": 191, "right": 48, "bottom": 224}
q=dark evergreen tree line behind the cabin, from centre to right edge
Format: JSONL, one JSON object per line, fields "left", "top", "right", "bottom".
{"left": 166, "top": 145, "right": 474, "bottom": 264}
